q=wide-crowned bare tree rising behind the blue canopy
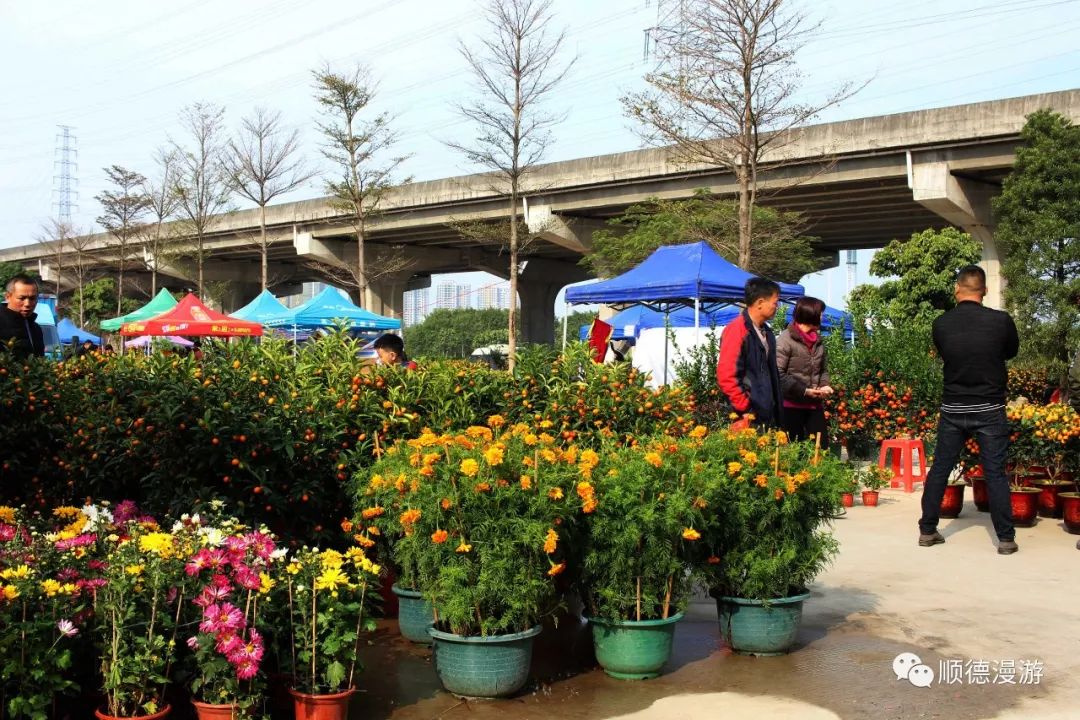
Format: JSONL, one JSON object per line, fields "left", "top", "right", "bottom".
{"left": 622, "top": 0, "right": 862, "bottom": 268}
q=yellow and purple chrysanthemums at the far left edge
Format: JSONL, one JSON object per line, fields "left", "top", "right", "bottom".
{"left": 0, "top": 506, "right": 90, "bottom": 718}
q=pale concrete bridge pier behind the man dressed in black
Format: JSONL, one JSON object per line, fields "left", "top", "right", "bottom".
{"left": 908, "top": 152, "right": 1004, "bottom": 309}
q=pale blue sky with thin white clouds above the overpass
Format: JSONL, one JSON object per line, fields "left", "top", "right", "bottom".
{"left": 0, "top": 0, "right": 1080, "bottom": 304}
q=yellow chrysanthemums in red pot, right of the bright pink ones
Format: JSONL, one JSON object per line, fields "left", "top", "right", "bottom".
{"left": 278, "top": 547, "right": 380, "bottom": 720}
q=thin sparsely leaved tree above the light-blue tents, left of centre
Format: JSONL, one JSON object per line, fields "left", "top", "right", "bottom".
{"left": 313, "top": 66, "right": 408, "bottom": 304}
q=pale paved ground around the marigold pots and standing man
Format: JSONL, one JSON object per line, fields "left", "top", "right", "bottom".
{"left": 351, "top": 490, "right": 1080, "bottom": 720}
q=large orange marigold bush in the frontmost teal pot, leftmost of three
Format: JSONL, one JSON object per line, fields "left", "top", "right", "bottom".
{"left": 360, "top": 421, "right": 595, "bottom": 697}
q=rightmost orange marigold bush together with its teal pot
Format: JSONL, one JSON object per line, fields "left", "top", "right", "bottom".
{"left": 700, "top": 429, "right": 851, "bottom": 655}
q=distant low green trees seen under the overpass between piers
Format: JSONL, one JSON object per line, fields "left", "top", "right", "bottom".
{"left": 404, "top": 310, "right": 516, "bottom": 357}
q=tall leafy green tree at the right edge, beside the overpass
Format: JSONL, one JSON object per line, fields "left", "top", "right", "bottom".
{"left": 994, "top": 110, "right": 1080, "bottom": 381}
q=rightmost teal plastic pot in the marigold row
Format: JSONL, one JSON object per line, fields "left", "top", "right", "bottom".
{"left": 716, "top": 593, "right": 810, "bottom": 655}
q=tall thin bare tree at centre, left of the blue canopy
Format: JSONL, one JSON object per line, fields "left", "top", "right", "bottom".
{"left": 449, "top": 0, "right": 573, "bottom": 369}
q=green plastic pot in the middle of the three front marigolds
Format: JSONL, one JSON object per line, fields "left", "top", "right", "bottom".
{"left": 589, "top": 613, "right": 683, "bottom": 680}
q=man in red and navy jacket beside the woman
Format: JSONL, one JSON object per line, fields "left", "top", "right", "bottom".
{"left": 716, "top": 277, "right": 783, "bottom": 427}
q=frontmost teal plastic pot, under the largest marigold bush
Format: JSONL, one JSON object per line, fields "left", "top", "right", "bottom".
{"left": 428, "top": 625, "right": 541, "bottom": 697}
